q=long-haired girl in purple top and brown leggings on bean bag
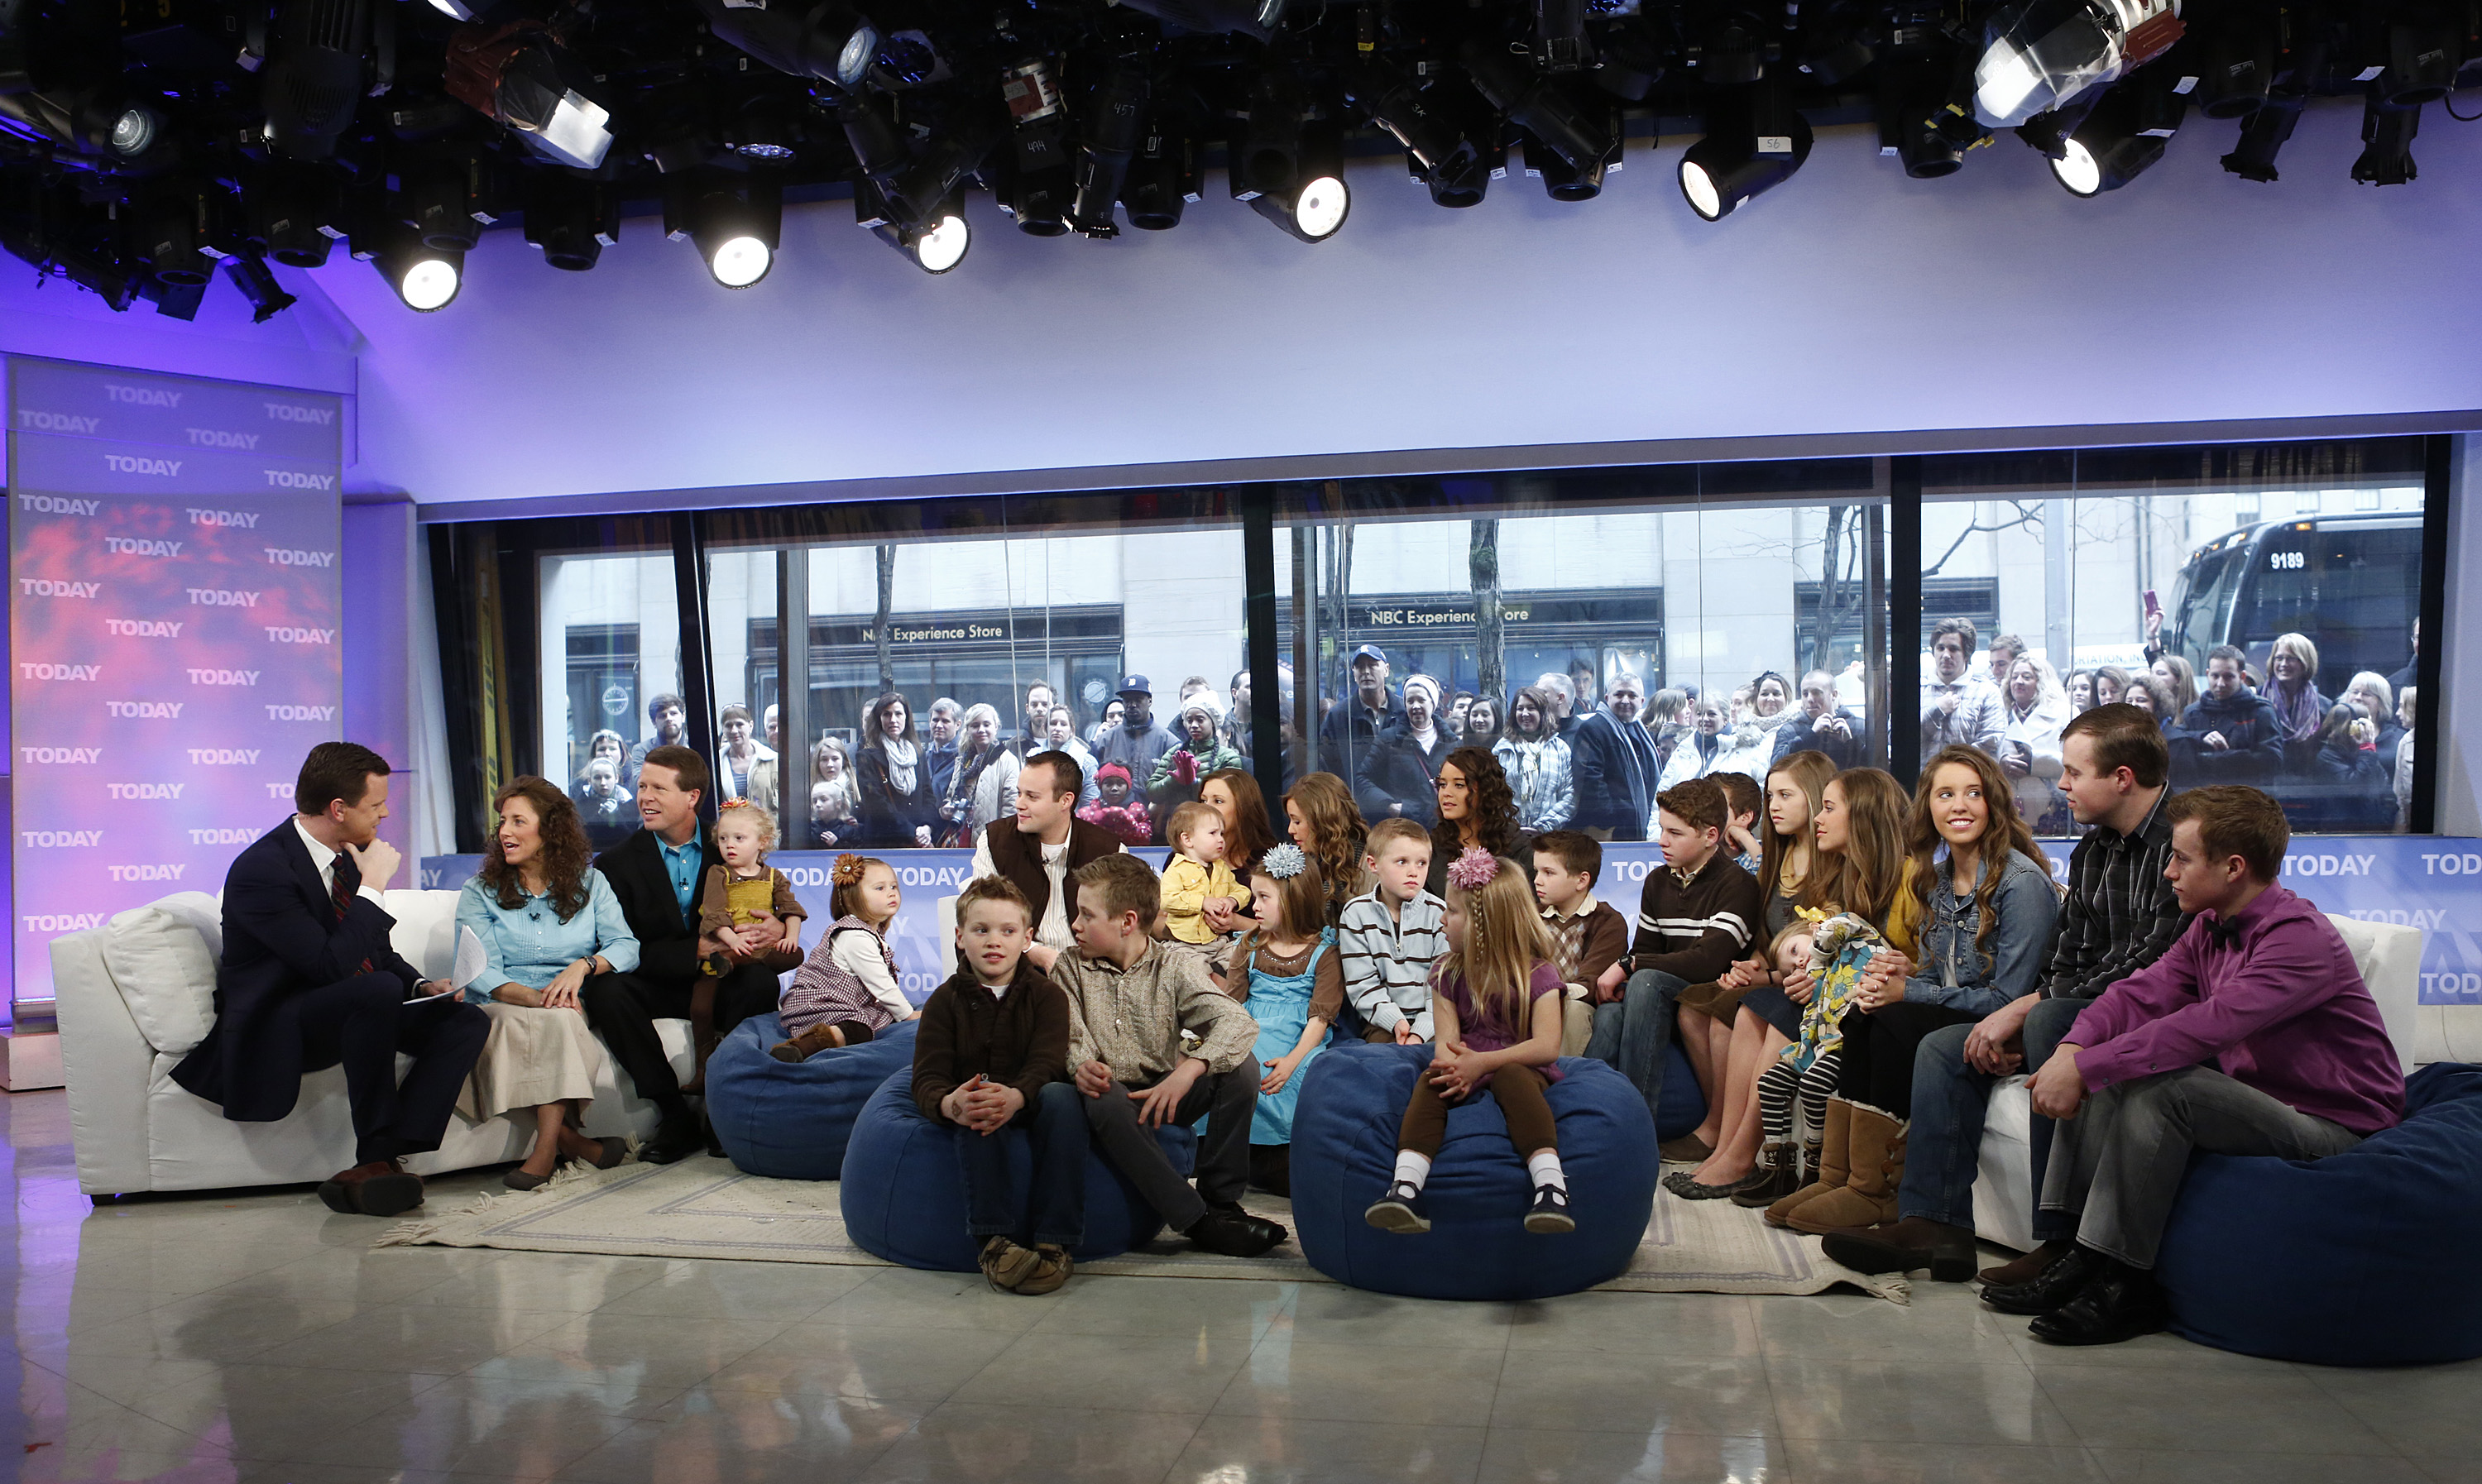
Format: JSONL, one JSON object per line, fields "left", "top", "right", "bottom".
{"left": 1363, "top": 846, "right": 1576, "bottom": 1233}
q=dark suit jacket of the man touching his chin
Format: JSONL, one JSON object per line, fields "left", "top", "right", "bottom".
{"left": 171, "top": 816, "right": 422, "bottom": 1124}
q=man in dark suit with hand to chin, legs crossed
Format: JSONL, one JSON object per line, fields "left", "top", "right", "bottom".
{"left": 171, "top": 742, "right": 491, "bottom": 1216}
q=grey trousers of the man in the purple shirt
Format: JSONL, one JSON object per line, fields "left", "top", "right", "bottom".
{"left": 2043, "top": 1067, "right": 2360, "bottom": 1268}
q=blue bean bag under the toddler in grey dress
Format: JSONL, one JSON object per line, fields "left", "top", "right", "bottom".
{"left": 707, "top": 1010, "right": 916, "bottom": 1179}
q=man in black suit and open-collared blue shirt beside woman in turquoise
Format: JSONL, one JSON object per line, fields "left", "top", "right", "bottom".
{"left": 578, "top": 747, "right": 777, "bottom": 1164}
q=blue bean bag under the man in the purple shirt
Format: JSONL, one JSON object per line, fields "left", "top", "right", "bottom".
{"left": 2154, "top": 1062, "right": 2482, "bottom": 1365}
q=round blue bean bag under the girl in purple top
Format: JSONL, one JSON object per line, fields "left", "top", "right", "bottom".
{"left": 1293, "top": 1045, "right": 1660, "bottom": 1300}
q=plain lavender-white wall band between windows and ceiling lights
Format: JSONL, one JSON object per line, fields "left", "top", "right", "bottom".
{"left": 295, "top": 107, "right": 2482, "bottom": 506}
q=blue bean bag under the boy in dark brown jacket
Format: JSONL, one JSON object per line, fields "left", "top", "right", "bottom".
{"left": 834, "top": 1062, "right": 1199, "bottom": 1273}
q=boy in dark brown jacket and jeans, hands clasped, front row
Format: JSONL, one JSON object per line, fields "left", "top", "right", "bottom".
{"left": 913, "top": 876, "right": 1087, "bottom": 1295}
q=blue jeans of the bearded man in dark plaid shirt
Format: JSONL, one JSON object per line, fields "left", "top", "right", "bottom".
{"left": 1896, "top": 1000, "right": 2092, "bottom": 1241}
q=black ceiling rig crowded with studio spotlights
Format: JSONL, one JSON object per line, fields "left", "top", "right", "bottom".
{"left": 0, "top": 0, "right": 2482, "bottom": 320}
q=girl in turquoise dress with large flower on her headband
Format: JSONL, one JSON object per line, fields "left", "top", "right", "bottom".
{"left": 1229, "top": 846, "right": 1345, "bottom": 1196}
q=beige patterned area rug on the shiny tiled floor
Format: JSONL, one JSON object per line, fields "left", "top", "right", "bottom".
{"left": 375, "top": 1154, "right": 1909, "bottom": 1303}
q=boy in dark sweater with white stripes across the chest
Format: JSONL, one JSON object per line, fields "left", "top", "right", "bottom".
{"left": 1586, "top": 779, "right": 1765, "bottom": 1159}
